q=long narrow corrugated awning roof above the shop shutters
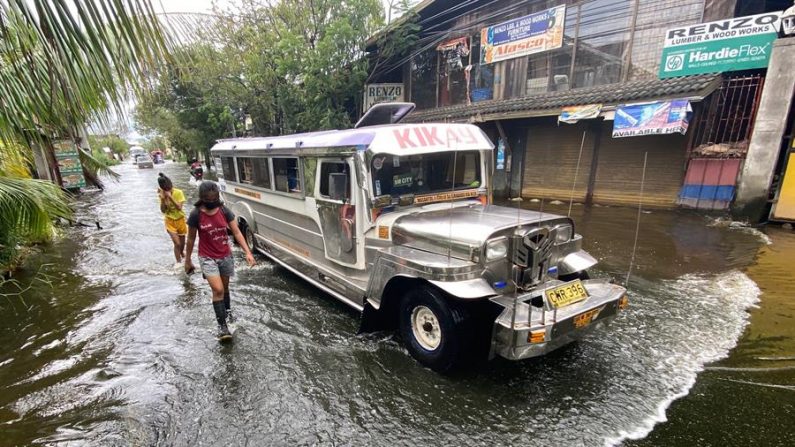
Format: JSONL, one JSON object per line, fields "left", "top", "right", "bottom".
{"left": 404, "top": 74, "right": 721, "bottom": 122}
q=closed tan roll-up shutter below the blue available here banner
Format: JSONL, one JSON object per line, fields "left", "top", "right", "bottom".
{"left": 593, "top": 121, "right": 687, "bottom": 207}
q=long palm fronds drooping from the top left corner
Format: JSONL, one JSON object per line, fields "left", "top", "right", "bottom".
{"left": 0, "top": 0, "right": 169, "bottom": 142}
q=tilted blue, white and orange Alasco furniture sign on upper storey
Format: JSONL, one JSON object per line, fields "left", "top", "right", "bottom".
{"left": 480, "top": 5, "right": 566, "bottom": 64}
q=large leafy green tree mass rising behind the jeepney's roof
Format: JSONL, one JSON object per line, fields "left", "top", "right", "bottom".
{"left": 136, "top": 0, "right": 383, "bottom": 145}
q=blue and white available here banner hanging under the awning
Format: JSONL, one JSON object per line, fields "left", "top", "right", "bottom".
{"left": 613, "top": 99, "right": 693, "bottom": 138}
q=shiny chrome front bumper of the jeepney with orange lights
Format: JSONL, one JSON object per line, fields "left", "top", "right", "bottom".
{"left": 491, "top": 280, "right": 626, "bottom": 360}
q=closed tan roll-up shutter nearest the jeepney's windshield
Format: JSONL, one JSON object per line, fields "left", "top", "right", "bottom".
{"left": 522, "top": 120, "right": 594, "bottom": 202}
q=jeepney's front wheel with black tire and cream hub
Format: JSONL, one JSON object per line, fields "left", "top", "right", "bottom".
{"left": 399, "top": 285, "right": 473, "bottom": 373}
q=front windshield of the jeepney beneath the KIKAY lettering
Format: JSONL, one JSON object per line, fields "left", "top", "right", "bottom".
{"left": 370, "top": 151, "right": 482, "bottom": 197}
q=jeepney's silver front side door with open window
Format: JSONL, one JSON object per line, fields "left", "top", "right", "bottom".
{"left": 315, "top": 158, "right": 357, "bottom": 264}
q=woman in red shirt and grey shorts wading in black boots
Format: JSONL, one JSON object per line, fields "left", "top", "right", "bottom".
{"left": 185, "top": 181, "right": 255, "bottom": 341}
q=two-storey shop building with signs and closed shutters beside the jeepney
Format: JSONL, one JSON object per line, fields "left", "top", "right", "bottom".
{"left": 370, "top": 0, "right": 792, "bottom": 221}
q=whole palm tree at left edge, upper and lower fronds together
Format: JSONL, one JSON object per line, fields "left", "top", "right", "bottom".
{"left": 0, "top": 0, "right": 169, "bottom": 270}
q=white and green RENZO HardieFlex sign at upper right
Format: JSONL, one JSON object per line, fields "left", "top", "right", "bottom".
{"left": 660, "top": 11, "right": 781, "bottom": 79}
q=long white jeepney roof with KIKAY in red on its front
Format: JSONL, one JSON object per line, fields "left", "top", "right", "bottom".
{"left": 212, "top": 123, "right": 494, "bottom": 155}
